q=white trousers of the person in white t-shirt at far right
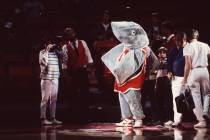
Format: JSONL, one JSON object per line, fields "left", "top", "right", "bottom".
{"left": 188, "top": 67, "right": 210, "bottom": 121}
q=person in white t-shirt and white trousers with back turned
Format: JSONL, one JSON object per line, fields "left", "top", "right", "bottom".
{"left": 182, "top": 29, "right": 210, "bottom": 127}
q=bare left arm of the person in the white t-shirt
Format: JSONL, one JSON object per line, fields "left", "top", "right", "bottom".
{"left": 182, "top": 55, "right": 192, "bottom": 85}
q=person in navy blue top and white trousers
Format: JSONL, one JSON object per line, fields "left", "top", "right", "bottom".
{"left": 166, "top": 32, "right": 188, "bottom": 126}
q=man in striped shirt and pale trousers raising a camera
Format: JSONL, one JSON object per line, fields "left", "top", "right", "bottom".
{"left": 39, "top": 34, "right": 66, "bottom": 125}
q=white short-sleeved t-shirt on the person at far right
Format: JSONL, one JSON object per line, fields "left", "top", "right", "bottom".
{"left": 183, "top": 41, "right": 210, "bottom": 68}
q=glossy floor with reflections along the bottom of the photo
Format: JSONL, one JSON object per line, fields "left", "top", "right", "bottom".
{"left": 0, "top": 123, "right": 210, "bottom": 140}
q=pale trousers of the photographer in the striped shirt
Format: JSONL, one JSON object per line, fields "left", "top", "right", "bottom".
{"left": 40, "top": 79, "right": 58, "bottom": 118}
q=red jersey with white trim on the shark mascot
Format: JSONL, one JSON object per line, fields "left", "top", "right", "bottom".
{"left": 114, "top": 49, "right": 147, "bottom": 93}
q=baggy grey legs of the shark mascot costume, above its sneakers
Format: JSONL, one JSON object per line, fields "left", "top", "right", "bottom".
{"left": 119, "top": 90, "right": 145, "bottom": 120}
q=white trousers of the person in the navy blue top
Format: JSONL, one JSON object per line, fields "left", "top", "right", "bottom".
{"left": 172, "top": 76, "right": 183, "bottom": 122}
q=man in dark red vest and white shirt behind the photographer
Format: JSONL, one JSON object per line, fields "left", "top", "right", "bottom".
{"left": 63, "top": 27, "right": 93, "bottom": 107}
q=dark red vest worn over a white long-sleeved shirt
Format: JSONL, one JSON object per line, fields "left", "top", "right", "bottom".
{"left": 67, "top": 40, "right": 88, "bottom": 70}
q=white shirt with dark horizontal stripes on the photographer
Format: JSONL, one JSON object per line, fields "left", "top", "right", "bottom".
{"left": 40, "top": 52, "right": 60, "bottom": 80}
